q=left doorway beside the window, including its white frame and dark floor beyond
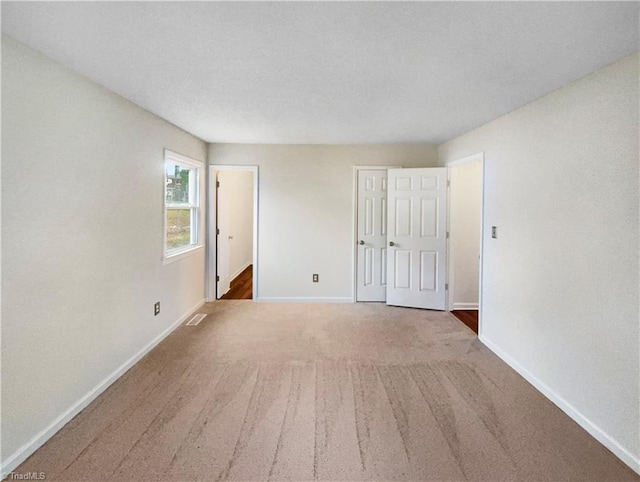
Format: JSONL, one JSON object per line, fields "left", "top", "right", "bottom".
{"left": 208, "top": 166, "right": 258, "bottom": 301}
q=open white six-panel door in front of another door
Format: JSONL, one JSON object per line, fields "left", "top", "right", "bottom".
{"left": 387, "top": 167, "right": 447, "bottom": 310}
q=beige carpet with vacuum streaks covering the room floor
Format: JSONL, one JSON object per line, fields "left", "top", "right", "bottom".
{"left": 15, "top": 301, "right": 640, "bottom": 481}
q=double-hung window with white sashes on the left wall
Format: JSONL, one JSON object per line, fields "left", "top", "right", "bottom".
{"left": 164, "top": 150, "right": 203, "bottom": 259}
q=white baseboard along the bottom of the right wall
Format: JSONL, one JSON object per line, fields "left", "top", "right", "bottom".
{"left": 478, "top": 334, "right": 640, "bottom": 474}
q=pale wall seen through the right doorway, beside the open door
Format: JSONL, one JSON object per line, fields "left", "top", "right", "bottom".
{"left": 449, "top": 161, "right": 482, "bottom": 310}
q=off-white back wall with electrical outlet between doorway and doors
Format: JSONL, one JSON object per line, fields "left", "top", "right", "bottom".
{"left": 209, "top": 144, "right": 437, "bottom": 301}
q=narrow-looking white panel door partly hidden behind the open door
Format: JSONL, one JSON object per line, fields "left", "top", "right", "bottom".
{"left": 356, "top": 169, "right": 387, "bottom": 301}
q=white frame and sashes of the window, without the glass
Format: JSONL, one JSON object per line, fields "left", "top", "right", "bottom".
{"left": 162, "top": 149, "right": 204, "bottom": 264}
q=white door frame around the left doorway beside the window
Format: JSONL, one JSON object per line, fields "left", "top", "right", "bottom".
{"left": 206, "top": 164, "right": 259, "bottom": 301}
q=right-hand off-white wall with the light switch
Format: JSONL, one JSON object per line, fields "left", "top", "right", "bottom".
{"left": 439, "top": 54, "right": 640, "bottom": 471}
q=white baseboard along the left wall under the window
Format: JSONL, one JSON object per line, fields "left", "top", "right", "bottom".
{"left": 0, "top": 299, "right": 204, "bottom": 479}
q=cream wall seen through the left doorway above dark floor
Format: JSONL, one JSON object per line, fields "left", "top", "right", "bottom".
{"left": 218, "top": 171, "right": 253, "bottom": 281}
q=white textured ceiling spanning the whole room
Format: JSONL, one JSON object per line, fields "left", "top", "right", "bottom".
{"left": 2, "top": 2, "right": 639, "bottom": 144}
